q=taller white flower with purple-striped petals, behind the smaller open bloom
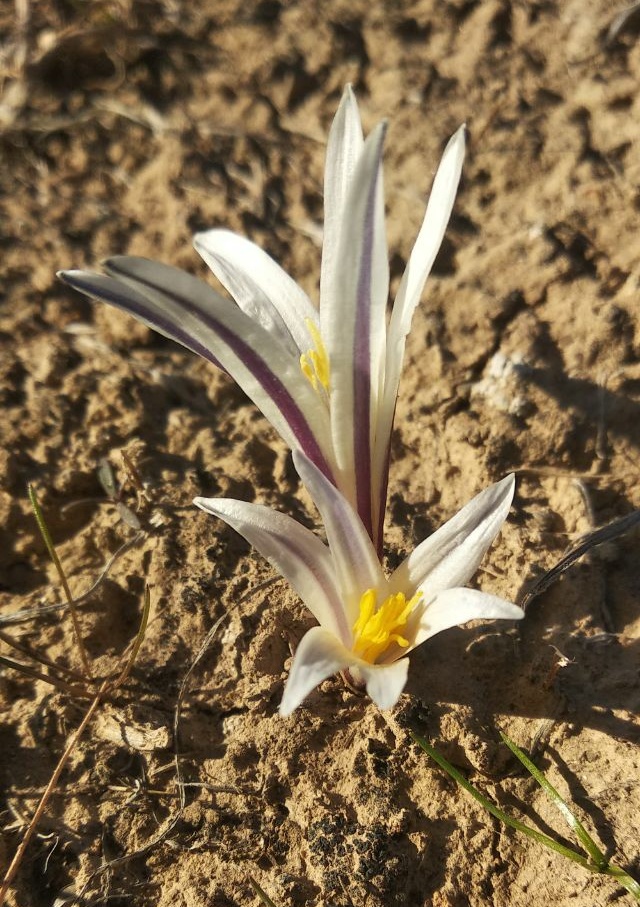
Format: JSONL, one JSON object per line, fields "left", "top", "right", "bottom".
{"left": 59, "top": 87, "right": 464, "bottom": 553}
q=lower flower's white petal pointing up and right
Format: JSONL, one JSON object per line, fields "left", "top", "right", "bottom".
{"left": 389, "top": 475, "right": 515, "bottom": 602}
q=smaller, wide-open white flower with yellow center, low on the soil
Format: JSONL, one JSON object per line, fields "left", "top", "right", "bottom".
{"left": 194, "top": 451, "right": 523, "bottom": 715}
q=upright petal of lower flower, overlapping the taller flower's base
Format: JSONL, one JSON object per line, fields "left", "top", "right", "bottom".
{"left": 293, "top": 451, "right": 386, "bottom": 628}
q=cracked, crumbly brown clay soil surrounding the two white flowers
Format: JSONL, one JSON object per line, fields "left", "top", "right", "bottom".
{"left": 0, "top": 0, "right": 640, "bottom": 907}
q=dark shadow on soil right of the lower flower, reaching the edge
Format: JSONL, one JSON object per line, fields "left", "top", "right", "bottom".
{"left": 407, "top": 573, "right": 640, "bottom": 741}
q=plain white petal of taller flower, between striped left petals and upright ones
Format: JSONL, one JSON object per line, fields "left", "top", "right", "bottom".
{"left": 193, "top": 230, "right": 318, "bottom": 359}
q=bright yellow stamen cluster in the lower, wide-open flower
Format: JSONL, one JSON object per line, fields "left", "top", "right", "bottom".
{"left": 353, "top": 589, "right": 422, "bottom": 664}
